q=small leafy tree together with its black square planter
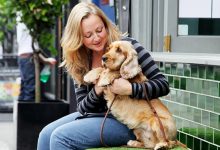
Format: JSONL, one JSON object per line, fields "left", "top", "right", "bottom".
{"left": 0, "top": 0, "right": 69, "bottom": 150}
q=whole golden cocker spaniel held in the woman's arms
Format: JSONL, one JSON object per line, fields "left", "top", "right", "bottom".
{"left": 84, "top": 41, "right": 177, "bottom": 149}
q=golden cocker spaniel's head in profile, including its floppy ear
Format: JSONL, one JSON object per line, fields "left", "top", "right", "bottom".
{"left": 102, "top": 41, "right": 141, "bottom": 79}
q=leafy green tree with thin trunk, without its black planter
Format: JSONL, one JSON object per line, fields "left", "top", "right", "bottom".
{"left": 13, "top": 0, "right": 68, "bottom": 102}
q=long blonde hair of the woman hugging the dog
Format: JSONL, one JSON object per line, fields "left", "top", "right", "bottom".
{"left": 61, "top": 2, "right": 122, "bottom": 84}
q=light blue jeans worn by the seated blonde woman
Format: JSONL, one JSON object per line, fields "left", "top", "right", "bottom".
{"left": 37, "top": 112, "right": 135, "bottom": 150}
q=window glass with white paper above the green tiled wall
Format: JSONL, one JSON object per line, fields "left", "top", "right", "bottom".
{"left": 178, "top": 0, "right": 220, "bottom": 36}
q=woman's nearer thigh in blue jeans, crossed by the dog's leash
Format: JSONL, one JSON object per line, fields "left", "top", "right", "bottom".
{"left": 50, "top": 117, "right": 135, "bottom": 150}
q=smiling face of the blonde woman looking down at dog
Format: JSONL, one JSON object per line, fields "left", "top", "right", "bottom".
{"left": 81, "top": 14, "right": 108, "bottom": 52}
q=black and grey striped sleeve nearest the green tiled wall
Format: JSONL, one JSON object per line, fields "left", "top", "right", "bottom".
{"left": 124, "top": 38, "right": 170, "bottom": 100}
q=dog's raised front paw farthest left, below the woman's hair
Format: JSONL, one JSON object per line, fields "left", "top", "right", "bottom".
{"left": 83, "top": 68, "right": 103, "bottom": 83}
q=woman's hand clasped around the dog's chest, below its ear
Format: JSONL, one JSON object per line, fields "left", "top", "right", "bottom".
{"left": 110, "top": 78, "right": 132, "bottom": 95}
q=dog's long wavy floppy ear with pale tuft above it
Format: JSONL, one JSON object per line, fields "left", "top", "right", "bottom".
{"left": 119, "top": 41, "right": 141, "bottom": 79}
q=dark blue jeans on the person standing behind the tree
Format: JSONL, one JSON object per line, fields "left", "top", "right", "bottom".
{"left": 18, "top": 58, "right": 35, "bottom": 101}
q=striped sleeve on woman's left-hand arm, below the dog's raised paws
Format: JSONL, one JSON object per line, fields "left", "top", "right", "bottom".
{"left": 74, "top": 83, "right": 106, "bottom": 114}
